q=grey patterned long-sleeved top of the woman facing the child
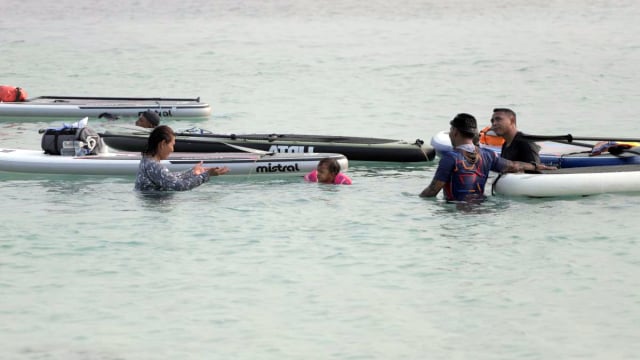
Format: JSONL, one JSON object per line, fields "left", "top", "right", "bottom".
{"left": 135, "top": 156, "right": 209, "bottom": 191}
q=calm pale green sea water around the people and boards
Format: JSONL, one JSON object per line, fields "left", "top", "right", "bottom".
{"left": 0, "top": 0, "right": 640, "bottom": 359}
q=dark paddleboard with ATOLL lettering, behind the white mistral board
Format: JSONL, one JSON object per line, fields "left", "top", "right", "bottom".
{"left": 100, "top": 129, "right": 435, "bottom": 162}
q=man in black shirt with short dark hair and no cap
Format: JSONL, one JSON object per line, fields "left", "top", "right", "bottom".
{"left": 491, "top": 108, "right": 540, "bottom": 164}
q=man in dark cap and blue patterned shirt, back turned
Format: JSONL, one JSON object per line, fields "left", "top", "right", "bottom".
{"left": 420, "top": 113, "right": 554, "bottom": 202}
